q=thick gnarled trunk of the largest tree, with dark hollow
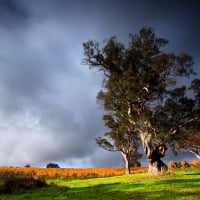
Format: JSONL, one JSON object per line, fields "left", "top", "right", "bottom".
{"left": 140, "top": 133, "right": 167, "bottom": 174}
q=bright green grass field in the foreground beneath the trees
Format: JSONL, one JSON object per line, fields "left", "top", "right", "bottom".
{"left": 0, "top": 168, "right": 200, "bottom": 200}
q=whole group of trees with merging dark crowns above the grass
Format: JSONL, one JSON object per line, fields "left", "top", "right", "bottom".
{"left": 83, "top": 27, "right": 200, "bottom": 174}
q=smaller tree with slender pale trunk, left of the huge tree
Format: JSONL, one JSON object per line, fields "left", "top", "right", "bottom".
{"left": 96, "top": 113, "right": 142, "bottom": 174}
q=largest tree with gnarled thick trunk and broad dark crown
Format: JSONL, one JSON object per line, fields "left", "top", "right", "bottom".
{"left": 83, "top": 28, "right": 200, "bottom": 173}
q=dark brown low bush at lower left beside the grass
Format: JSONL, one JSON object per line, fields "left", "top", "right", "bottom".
{"left": 2, "top": 177, "right": 47, "bottom": 194}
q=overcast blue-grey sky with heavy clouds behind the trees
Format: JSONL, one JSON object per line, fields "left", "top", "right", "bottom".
{"left": 0, "top": 0, "right": 200, "bottom": 167}
